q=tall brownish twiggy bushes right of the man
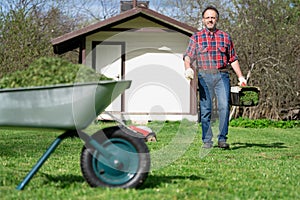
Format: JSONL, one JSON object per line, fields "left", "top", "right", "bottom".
{"left": 230, "top": 0, "right": 300, "bottom": 119}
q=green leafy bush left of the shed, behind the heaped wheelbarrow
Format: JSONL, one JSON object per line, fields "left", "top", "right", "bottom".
{"left": 0, "top": 8, "right": 51, "bottom": 77}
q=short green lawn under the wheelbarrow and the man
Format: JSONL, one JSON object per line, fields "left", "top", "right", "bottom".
{"left": 0, "top": 122, "right": 300, "bottom": 200}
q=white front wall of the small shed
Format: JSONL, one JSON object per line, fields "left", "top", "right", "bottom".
{"left": 85, "top": 28, "right": 197, "bottom": 121}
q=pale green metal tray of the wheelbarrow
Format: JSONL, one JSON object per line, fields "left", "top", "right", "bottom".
{"left": 0, "top": 81, "right": 131, "bottom": 130}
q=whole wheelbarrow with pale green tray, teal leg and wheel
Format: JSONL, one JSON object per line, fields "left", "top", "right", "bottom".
{"left": 0, "top": 80, "right": 150, "bottom": 190}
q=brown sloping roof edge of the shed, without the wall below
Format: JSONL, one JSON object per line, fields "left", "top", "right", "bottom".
{"left": 51, "top": 7, "right": 197, "bottom": 54}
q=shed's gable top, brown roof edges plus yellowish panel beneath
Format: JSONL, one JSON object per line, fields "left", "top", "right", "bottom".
{"left": 51, "top": 7, "right": 197, "bottom": 53}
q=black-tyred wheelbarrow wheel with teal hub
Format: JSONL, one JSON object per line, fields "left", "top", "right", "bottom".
{"left": 80, "top": 126, "right": 150, "bottom": 188}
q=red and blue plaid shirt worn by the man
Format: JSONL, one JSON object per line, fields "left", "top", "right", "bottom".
{"left": 184, "top": 28, "right": 238, "bottom": 70}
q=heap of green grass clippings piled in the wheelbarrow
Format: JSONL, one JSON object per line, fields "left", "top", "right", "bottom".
{"left": 0, "top": 57, "right": 111, "bottom": 88}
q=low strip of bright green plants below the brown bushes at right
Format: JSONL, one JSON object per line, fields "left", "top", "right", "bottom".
{"left": 229, "top": 117, "right": 300, "bottom": 129}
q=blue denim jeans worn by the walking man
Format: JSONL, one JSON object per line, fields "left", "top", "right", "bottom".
{"left": 198, "top": 72, "right": 230, "bottom": 143}
